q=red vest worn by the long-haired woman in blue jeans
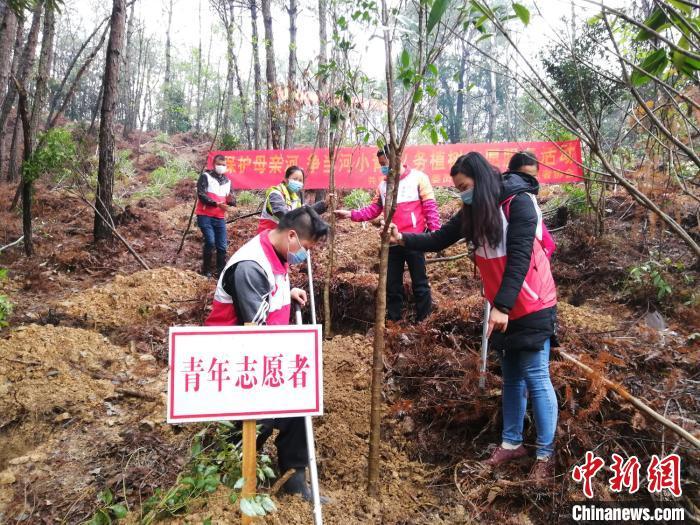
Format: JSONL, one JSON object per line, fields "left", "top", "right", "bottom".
{"left": 475, "top": 193, "right": 557, "bottom": 320}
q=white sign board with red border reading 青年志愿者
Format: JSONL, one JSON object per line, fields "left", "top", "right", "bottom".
{"left": 167, "top": 325, "right": 323, "bottom": 423}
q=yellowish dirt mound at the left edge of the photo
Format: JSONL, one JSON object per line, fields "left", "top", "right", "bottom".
{"left": 0, "top": 325, "right": 125, "bottom": 469}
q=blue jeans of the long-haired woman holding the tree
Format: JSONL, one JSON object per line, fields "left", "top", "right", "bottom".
{"left": 501, "top": 339, "right": 558, "bottom": 458}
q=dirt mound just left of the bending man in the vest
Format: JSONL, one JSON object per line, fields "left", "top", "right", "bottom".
{"left": 57, "top": 267, "right": 213, "bottom": 327}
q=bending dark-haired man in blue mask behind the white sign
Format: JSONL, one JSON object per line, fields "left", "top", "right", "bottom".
{"left": 204, "top": 206, "right": 328, "bottom": 501}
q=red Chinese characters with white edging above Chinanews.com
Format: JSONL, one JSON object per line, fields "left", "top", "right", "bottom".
{"left": 571, "top": 451, "right": 683, "bottom": 498}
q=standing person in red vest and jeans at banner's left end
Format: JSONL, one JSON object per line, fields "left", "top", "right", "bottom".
{"left": 195, "top": 155, "right": 235, "bottom": 277}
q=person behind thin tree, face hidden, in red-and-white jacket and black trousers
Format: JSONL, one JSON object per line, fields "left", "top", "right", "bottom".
{"left": 335, "top": 149, "right": 441, "bottom": 322}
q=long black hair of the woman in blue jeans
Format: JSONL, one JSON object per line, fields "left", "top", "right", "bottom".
{"left": 450, "top": 151, "right": 503, "bottom": 248}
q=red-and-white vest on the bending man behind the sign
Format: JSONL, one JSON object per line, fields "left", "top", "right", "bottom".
{"left": 204, "top": 232, "right": 291, "bottom": 326}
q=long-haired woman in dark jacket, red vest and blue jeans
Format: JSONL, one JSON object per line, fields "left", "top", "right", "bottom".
{"left": 392, "top": 152, "right": 557, "bottom": 483}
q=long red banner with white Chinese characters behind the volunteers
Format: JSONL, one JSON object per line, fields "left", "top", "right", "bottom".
{"left": 207, "top": 140, "right": 583, "bottom": 189}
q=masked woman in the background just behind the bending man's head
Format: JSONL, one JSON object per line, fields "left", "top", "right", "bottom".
{"left": 258, "top": 166, "right": 331, "bottom": 233}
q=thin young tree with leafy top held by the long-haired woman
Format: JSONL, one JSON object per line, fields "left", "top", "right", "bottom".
{"left": 360, "top": 0, "right": 463, "bottom": 497}
